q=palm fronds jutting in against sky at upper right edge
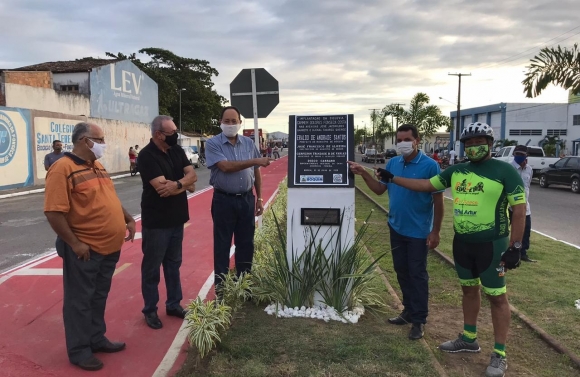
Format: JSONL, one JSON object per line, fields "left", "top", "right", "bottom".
{"left": 522, "top": 43, "right": 580, "bottom": 98}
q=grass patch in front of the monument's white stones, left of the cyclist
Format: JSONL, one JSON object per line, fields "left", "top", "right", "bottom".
{"left": 177, "top": 304, "right": 438, "bottom": 377}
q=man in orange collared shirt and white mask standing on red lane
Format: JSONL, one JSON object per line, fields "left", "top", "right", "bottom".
{"left": 44, "top": 123, "right": 135, "bottom": 370}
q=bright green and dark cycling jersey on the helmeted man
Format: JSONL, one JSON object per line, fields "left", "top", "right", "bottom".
{"left": 431, "top": 159, "right": 526, "bottom": 243}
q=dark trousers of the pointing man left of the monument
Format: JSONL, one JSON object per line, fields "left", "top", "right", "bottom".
{"left": 211, "top": 191, "right": 256, "bottom": 285}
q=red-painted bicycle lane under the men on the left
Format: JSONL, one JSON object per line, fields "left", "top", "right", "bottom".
{"left": 0, "top": 158, "right": 287, "bottom": 377}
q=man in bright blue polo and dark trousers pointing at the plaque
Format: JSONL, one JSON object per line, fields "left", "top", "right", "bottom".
{"left": 348, "top": 124, "right": 443, "bottom": 340}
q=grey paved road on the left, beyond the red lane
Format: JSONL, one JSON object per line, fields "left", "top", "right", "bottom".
{"left": 0, "top": 166, "right": 209, "bottom": 272}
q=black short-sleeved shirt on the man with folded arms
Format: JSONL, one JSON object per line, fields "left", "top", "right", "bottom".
{"left": 137, "top": 141, "right": 191, "bottom": 229}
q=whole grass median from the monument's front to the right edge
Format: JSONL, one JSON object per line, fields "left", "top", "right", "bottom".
{"left": 177, "top": 182, "right": 580, "bottom": 377}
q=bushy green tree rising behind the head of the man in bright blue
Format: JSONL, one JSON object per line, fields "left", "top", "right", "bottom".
{"left": 383, "top": 93, "right": 451, "bottom": 137}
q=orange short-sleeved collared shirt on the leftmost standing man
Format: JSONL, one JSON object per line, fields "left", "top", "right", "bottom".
{"left": 44, "top": 152, "right": 126, "bottom": 255}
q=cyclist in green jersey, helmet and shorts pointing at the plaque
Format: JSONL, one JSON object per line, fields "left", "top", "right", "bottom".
{"left": 377, "top": 122, "right": 526, "bottom": 377}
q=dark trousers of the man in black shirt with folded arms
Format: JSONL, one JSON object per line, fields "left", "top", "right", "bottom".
{"left": 141, "top": 225, "right": 183, "bottom": 314}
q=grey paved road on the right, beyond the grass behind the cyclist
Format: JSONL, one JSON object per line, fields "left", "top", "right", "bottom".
{"left": 356, "top": 154, "right": 580, "bottom": 246}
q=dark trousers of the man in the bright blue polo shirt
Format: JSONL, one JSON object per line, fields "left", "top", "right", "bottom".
{"left": 389, "top": 226, "right": 429, "bottom": 323}
